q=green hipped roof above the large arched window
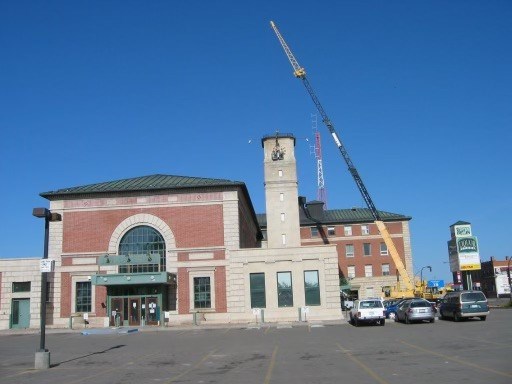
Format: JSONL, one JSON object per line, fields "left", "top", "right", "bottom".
{"left": 40, "top": 175, "right": 246, "bottom": 200}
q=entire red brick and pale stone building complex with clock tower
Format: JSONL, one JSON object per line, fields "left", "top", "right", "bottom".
{"left": 0, "top": 134, "right": 412, "bottom": 328}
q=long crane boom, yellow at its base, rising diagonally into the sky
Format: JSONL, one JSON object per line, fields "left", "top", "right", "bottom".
{"left": 270, "top": 21, "right": 414, "bottom": 294}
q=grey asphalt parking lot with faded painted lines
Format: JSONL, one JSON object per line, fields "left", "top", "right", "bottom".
{"left": 0, "top": 309, "right": 512, "bottom": 384}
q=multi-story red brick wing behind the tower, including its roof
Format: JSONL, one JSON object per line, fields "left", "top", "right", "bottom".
{"left": 258, "top": 201, "right": 413, "bottom": 298}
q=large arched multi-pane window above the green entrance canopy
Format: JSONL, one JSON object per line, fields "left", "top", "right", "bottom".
{"left": 118, "top": 225, "right": 166, "bottom": 273}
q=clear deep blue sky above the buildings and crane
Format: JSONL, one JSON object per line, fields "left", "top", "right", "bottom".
{"left": 0, "top": 0, "right": 512, "bottom": 281}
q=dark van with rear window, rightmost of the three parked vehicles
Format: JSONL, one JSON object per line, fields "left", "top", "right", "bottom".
{"left": 439, "top": 291, "right": 489, "bottom": 321}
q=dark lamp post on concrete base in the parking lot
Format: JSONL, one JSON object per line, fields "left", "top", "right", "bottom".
{"left": 32, "top": 208, "right": 62, "bottom": 369}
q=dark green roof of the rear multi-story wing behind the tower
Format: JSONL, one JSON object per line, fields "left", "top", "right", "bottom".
{"left": 256, "top": 208, "right": 412, "bottom": 228}
